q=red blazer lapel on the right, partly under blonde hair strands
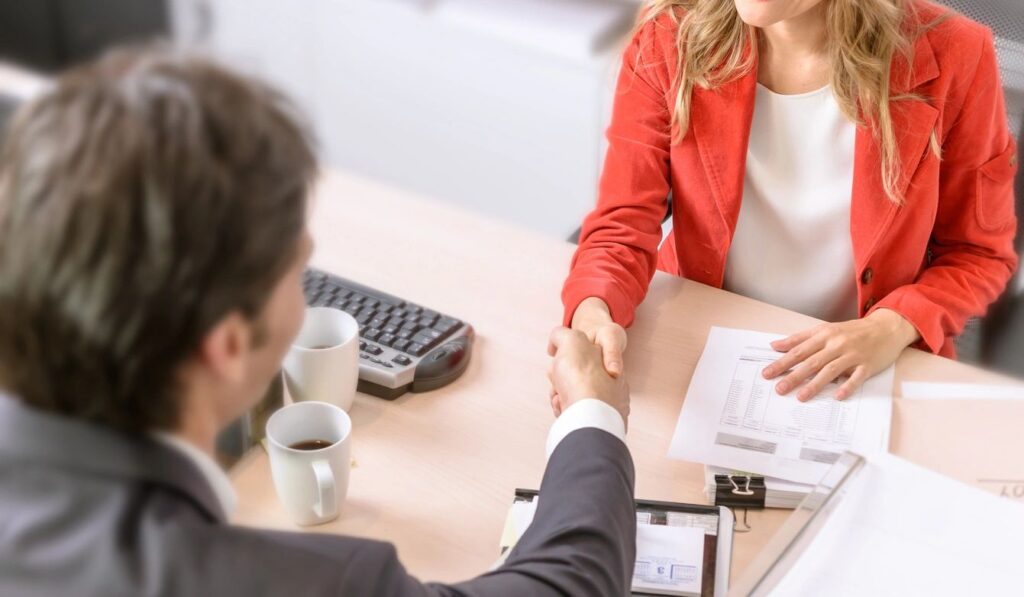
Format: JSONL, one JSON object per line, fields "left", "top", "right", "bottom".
{"left": 850, "top": 36, "right": 939, "bottom": 272}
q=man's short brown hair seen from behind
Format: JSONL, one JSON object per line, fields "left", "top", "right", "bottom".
{"left": 0, "top": 44, "right": 315, "bottom": 432}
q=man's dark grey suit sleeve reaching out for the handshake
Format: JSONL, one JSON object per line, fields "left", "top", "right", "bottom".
{"left": 374, "top": 428, "right": 636, "bottom": 597}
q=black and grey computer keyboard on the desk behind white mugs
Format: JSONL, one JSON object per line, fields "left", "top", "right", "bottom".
{"left": 302, "top": 268, "right": 473, "bottom": 400}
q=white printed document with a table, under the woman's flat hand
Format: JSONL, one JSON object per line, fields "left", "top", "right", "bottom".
{"left": 669, "top": 328, "right": 894, "bottom": 483}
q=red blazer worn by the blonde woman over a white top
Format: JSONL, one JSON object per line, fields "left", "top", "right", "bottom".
{"left": 562, "top": 2, "right": 1017, "bottom": 356}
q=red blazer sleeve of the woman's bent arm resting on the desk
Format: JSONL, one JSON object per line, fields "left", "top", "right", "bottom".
{"left": 871, "top": 32, "right": 1018, "bottom": 352}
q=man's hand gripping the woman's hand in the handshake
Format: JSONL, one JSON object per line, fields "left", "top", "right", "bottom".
{"left": 548, "top": 328, "right": 630, "bottom": 421}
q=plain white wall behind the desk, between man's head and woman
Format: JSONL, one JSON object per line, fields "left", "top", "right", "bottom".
{"left": 178, "top": 0, "right": 635, "bottom": 238}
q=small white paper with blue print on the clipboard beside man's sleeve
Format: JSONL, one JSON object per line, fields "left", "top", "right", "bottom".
{"left": 633, "top": 519, "right": 705, "bottom": 595}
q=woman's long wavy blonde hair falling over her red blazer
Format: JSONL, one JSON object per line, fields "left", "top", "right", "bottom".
{"left": 640, "top": 0, "right": 940, "bottom": 204}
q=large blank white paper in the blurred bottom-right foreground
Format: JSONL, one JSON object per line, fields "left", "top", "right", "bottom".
{"left": 771, "top": 454, "right": 1024, "bottom": 597}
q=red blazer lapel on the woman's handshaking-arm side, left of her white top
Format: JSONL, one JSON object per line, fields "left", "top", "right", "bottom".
{"left": 690, "top": 60, "right": 758, "bottom": 251}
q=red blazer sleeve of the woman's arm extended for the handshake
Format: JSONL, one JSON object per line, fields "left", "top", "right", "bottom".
{"left": 562, "top": 14, "right": 673, "bottom": 327}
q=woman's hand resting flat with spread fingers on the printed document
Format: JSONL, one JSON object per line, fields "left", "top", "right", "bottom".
{"left": 763, "top": 309, "right": 920, "bottom": 401}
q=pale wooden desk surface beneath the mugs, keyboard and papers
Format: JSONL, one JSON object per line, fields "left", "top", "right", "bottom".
{"left": 231, "top": 167, "right": 1004, "bottom": 582}
